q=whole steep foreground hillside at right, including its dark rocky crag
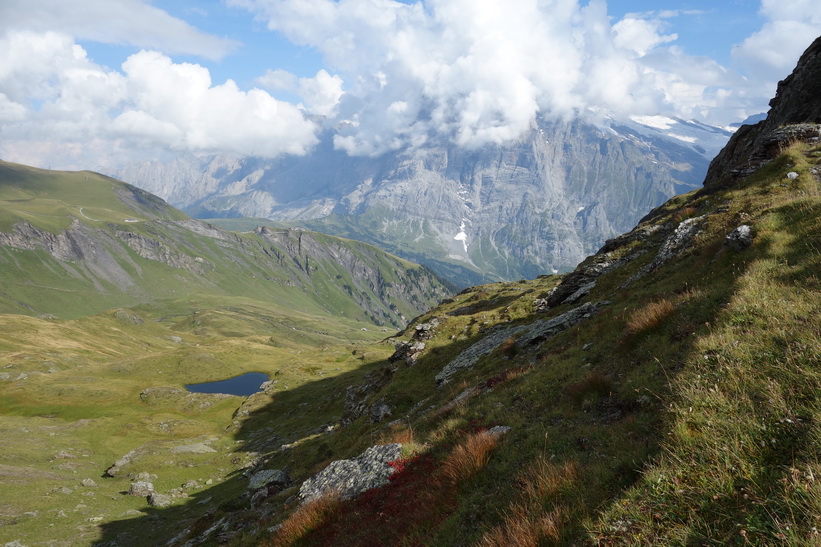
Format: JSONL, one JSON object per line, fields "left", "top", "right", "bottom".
{"left": 78, "top": 39, "right": 821, "bottom": 546}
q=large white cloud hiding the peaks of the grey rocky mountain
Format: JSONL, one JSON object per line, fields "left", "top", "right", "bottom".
{"left": 229, "top": 0, "right": 764, "bottom": 155}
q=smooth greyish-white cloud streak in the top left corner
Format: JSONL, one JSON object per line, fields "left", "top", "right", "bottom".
{"left": 0, "top": 0, "right": 239, "bottom": 59}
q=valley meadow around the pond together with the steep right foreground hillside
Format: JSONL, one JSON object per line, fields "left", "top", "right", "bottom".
{"left": 0, "top": 39, "right": 821, "bottom": 546}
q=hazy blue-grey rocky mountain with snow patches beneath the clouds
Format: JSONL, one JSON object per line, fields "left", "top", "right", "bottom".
{"left": 110, "top": 117, "right": 729, "bottom": 285}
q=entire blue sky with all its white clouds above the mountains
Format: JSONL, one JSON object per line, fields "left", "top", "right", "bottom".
{"left": 0, "top": 0, "right": 821, "bottom": 169}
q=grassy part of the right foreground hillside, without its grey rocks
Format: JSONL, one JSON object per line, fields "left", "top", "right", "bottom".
{"left": 224, "top": 140, "right": 821, "bottom": 545}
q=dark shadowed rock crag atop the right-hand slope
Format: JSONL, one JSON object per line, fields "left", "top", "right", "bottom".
{"left": 704, "top": 37, "right": 821, "bottom": 191}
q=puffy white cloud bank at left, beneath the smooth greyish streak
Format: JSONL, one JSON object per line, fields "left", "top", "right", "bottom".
{"left": 0, "top": 32, "right": 317, "bottom": 167}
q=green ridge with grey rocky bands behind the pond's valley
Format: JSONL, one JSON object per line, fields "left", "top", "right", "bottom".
{"left": 0, "top": 162, "right": 447, "bottom": 327}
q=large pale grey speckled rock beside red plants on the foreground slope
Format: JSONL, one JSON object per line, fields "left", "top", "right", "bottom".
{"left": 299, "top": 444, "right": 402, "bottom": 502}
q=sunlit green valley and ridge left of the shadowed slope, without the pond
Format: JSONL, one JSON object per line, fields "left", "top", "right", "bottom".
{"left": 0, "top": 162, "right": 448, "bottom": 545}
